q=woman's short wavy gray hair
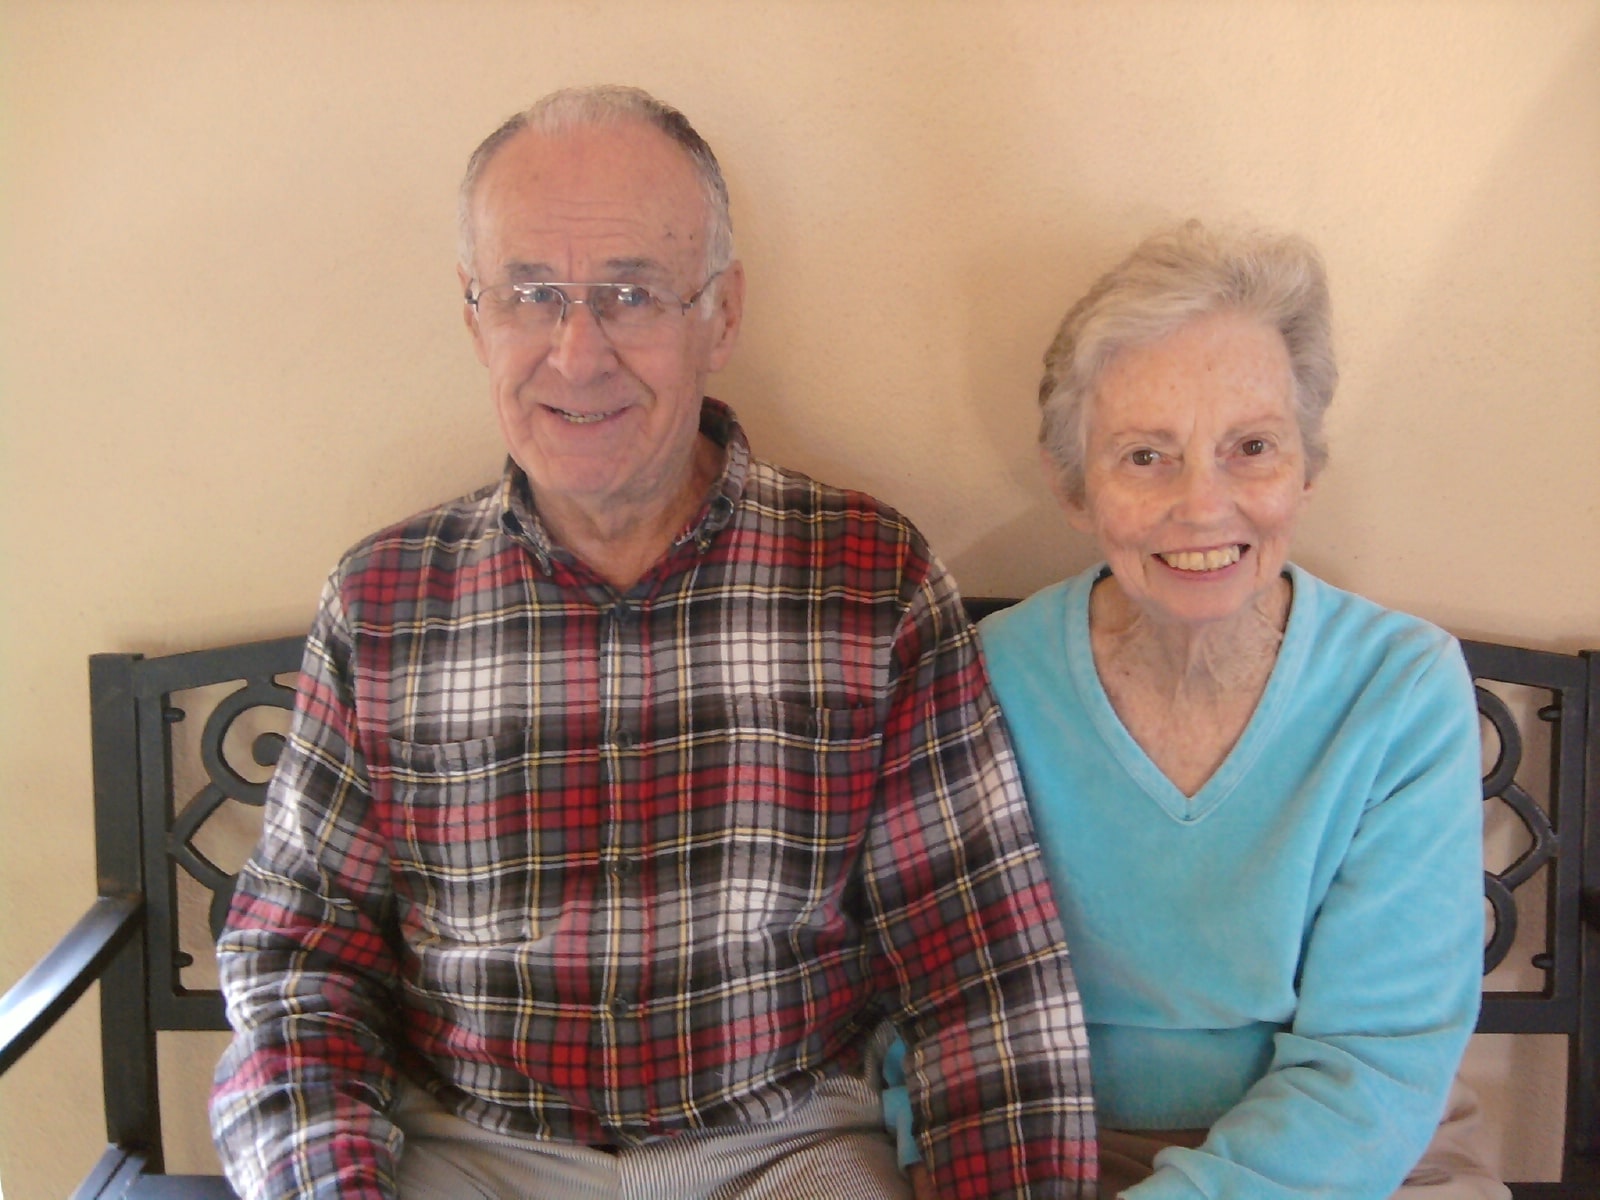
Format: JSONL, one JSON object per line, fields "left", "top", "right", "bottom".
{"left": 1038, "top": 221, "right": 1339, "bottom": 502}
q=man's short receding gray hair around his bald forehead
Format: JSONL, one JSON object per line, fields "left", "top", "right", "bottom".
{"left": 456, "top": 83, "right": 733, "bottom": 289}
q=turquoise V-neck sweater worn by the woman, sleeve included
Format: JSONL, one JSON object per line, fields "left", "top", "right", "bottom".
{"left": 891, "top": 566, "right": 1483, "bottom": 1200}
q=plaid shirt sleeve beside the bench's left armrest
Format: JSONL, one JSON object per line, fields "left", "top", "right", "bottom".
{"left": 211, "top": 582, "right": 400, "bottom": 1200}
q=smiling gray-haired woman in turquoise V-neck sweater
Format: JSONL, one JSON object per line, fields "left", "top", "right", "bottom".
{"left": 902, "top": 222, "right": 1506, "bottom": 1200}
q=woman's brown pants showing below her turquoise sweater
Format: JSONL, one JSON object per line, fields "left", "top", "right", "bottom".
{"left": 1099, "top": 1080, "right": 1510, "bottom": 1200}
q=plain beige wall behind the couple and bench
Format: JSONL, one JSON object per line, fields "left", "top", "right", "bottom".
{"left": 0, "top": 0, "right": 1600, "bottom": 1200}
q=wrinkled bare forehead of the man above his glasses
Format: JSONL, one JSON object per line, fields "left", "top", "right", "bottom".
{"left": 472, "top": 120, "right": 710, "bottom": 285}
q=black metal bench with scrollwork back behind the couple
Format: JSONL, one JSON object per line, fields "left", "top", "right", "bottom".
{"left": 0, "top": 624, "right": 1600, "bottom": 1200}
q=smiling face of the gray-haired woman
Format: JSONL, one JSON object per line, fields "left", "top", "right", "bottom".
{"left": 1064, "top": 312, "right": 1310, "bottom": 626}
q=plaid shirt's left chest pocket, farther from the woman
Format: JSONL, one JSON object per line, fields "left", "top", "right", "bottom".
{"left": 373, "top": 730, "right": 549, "bottom": 944}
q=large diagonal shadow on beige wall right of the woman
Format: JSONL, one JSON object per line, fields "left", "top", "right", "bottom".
{"left": 1306, "top": 14, "right": 1600, "bottom": 652}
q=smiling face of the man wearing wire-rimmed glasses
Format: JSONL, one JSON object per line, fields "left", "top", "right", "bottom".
{"left": 461, "top": 122, "right": 744, "bottom": 522}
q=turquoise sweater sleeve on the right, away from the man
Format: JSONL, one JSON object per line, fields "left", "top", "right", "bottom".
{"left": 1123, "top": 642, "right": 1483, "bottom": 1200}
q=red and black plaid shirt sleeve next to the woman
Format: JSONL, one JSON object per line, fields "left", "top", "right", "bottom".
{"left": 864, "top": 562, "right": 1094, "bottom": 1200}
